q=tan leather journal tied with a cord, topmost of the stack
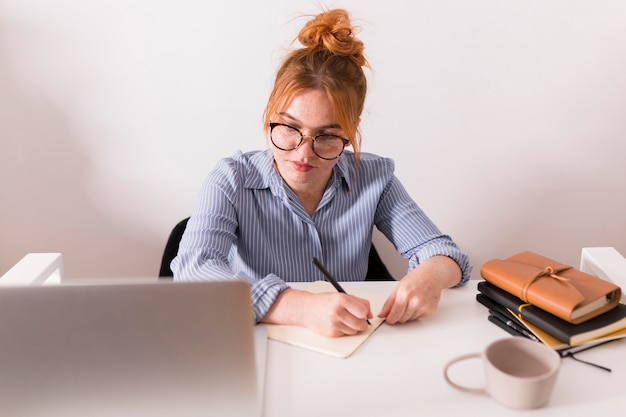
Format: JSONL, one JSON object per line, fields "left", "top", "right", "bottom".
{"left": 480, "top": 251, "right": 622, "bottom": 324}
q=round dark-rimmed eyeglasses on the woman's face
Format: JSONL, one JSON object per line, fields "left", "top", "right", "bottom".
{"left": 270, "top": 123, "right": 350, "bottom": 161}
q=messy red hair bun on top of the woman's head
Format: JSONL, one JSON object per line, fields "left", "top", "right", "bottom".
{"left": 298, "top": 9, "right": 367, "bottom": 66}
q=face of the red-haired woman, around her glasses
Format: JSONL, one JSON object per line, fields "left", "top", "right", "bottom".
{"left": 272, "top": 90, "right": 344, "bottom": 193}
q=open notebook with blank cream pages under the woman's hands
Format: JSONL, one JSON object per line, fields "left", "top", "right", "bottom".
{"left": 263, "top": 281, "right": 386, "bottom": 358}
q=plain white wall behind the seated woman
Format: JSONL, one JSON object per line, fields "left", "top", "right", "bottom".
{"left": 0, "top": 0, "right": 626, "bottom": 277}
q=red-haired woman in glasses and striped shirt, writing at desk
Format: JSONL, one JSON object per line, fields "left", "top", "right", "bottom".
{"left": 172, "top": 10, "right": 471, "bottom": 336}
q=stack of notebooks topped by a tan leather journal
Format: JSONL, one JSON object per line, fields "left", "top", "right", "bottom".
{"left": 476, "top": 251, "right": 626, "bottom": 352}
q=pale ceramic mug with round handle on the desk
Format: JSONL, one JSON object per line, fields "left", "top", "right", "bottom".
{"left": 444, "top": 337, "right": 561, "bottom": 409}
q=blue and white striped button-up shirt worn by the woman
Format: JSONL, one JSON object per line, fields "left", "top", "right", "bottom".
{"left": 171, "top": 150, "right": 471, "bottom": 321}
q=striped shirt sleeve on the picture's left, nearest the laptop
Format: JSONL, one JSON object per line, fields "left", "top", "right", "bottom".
{"left": 171, "top": 158, "right": 288, "bottom": 322}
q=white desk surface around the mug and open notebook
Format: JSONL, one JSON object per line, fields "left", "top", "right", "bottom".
{"left": 264, "top": 280, "right": 626, "bottom": 417}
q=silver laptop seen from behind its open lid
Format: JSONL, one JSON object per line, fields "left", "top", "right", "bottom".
{"left": 0, "top": 281, "right": 266, "bottom": 417}
